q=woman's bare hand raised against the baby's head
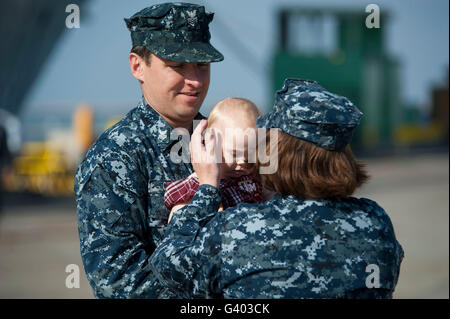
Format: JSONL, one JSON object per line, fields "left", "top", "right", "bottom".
{"left": 189, "top": 120, "right": 221, "bottom": 187}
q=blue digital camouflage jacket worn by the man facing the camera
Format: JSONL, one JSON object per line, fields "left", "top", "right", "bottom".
{"left": 75, "top": 98, "right": 204, "bottom": 298}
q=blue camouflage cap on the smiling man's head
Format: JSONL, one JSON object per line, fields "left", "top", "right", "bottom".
{"left": 125, "top": 2, "right": 223, "bottom": 62}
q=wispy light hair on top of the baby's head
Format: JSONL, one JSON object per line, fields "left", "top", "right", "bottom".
{"left": 208, "top": 97, "right": 262, "bottom": 127}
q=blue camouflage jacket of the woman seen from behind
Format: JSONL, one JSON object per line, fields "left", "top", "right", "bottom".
{"left": 150, "top": 185, "right": 403, "bottom": 298}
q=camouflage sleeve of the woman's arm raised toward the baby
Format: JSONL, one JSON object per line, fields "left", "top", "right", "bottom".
{"left": 150, "top": 184, "right": 221, "bottom": 298}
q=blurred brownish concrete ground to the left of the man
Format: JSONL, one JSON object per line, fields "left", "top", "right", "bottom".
{"left": 0, "top": 197, "right": 93, "bottom": 298}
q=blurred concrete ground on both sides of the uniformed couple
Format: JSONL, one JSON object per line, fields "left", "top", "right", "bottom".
{"left": 0, "top": 154, "right": 449, "bottom": 298}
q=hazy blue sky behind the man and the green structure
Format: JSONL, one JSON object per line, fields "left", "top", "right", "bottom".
{"left": 25, "top": 0, "right": 449, "bottom": 119}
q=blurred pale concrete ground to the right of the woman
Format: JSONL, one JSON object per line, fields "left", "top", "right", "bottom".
{"left": 356, "top": 154, "right": 449, "bottom": 299}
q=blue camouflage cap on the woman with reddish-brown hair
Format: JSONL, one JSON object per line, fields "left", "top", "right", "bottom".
{"left": 256, "top": 79, "right": 363, "bottom": 150}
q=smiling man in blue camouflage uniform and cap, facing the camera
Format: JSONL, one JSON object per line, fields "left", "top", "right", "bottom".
{"left": 75, "top": 3, "right": 223, "bottom": 298}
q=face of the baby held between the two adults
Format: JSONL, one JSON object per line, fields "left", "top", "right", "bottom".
{"left": 211, "top": 119, "right": 257, "bottom": 178}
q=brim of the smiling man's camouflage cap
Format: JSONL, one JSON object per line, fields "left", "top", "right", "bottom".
{"left": 147, "top": 42, "right": 224, "bottom": 63}
